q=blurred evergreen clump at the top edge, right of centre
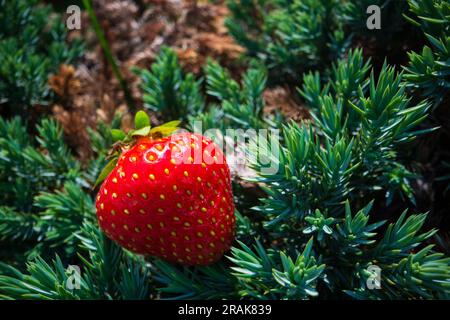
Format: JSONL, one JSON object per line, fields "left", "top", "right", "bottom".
{"left": 226, "top": 0, "right": 349, "bottom": 80}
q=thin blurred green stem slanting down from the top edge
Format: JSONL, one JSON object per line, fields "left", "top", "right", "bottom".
{"left": 83, "top": 0, "right": 136, "bottom": 113}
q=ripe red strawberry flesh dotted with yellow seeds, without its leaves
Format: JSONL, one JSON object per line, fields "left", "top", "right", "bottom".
{"left": 96, "top": 114, "right": 235, "bottom": 265}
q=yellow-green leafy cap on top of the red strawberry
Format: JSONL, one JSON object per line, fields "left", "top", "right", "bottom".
{"left": 93, "top": 110, "right": 181, "bottom": 189}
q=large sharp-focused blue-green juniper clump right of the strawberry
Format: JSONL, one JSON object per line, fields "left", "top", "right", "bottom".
{"left": 223, "top": 50, "right": 449, "bottom": 299}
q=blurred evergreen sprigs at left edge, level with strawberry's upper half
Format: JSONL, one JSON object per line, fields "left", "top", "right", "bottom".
{"left": 0, "top": 117, "right": 83, "bottom": 212}
